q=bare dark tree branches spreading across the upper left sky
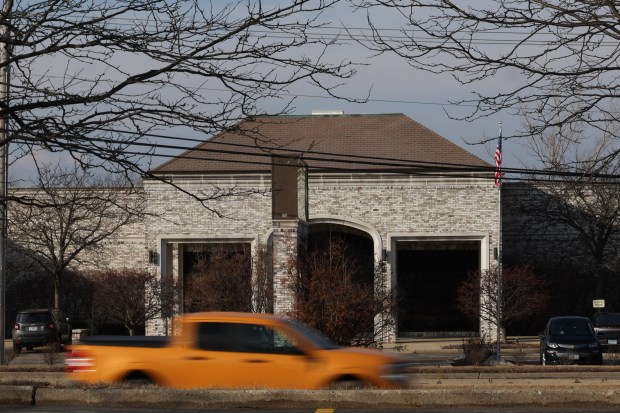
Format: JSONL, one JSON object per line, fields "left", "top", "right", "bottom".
{"left": 0, "top": 0, "right": 355, "bottom": 198}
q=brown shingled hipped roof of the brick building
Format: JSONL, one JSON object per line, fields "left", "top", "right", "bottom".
{"left": 151, "top": 114, "right": 491, "bottom": 174}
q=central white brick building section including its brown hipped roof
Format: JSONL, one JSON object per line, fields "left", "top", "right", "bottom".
{"left": 144, "top": 114, "right": 499, "bottom": 339}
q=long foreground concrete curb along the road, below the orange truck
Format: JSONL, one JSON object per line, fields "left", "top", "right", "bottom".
{"left": 32, "top": 386, "right": 620, "bottom": 409}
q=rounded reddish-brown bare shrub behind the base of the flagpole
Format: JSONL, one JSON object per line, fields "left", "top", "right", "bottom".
{"left": 457, "top": 265, "right": 549, "bottom": 338}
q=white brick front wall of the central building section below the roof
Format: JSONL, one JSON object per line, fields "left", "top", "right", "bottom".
{"left": 145, "top": 174, "right": 499, "bottom": 338}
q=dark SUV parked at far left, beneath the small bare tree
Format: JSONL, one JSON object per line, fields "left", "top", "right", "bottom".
{"left": 12, "top": 308, "right": 72, "bottom": 352}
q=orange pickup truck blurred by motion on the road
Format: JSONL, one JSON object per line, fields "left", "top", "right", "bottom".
{"left": 65, "top": 313, "right": 411, "bottom": 389}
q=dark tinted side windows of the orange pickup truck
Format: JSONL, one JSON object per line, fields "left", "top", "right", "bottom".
{"left": 198, "top": 322, "right": 299, "bottom": 354}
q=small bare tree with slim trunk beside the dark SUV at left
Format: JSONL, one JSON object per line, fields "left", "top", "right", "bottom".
{"left": 9, "top": 161, "right": 142, "bottom": 307}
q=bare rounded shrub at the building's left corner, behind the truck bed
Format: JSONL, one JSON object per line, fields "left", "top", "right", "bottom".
{"left": 91, "top": 268, "right": 169, "bottom": 336}
